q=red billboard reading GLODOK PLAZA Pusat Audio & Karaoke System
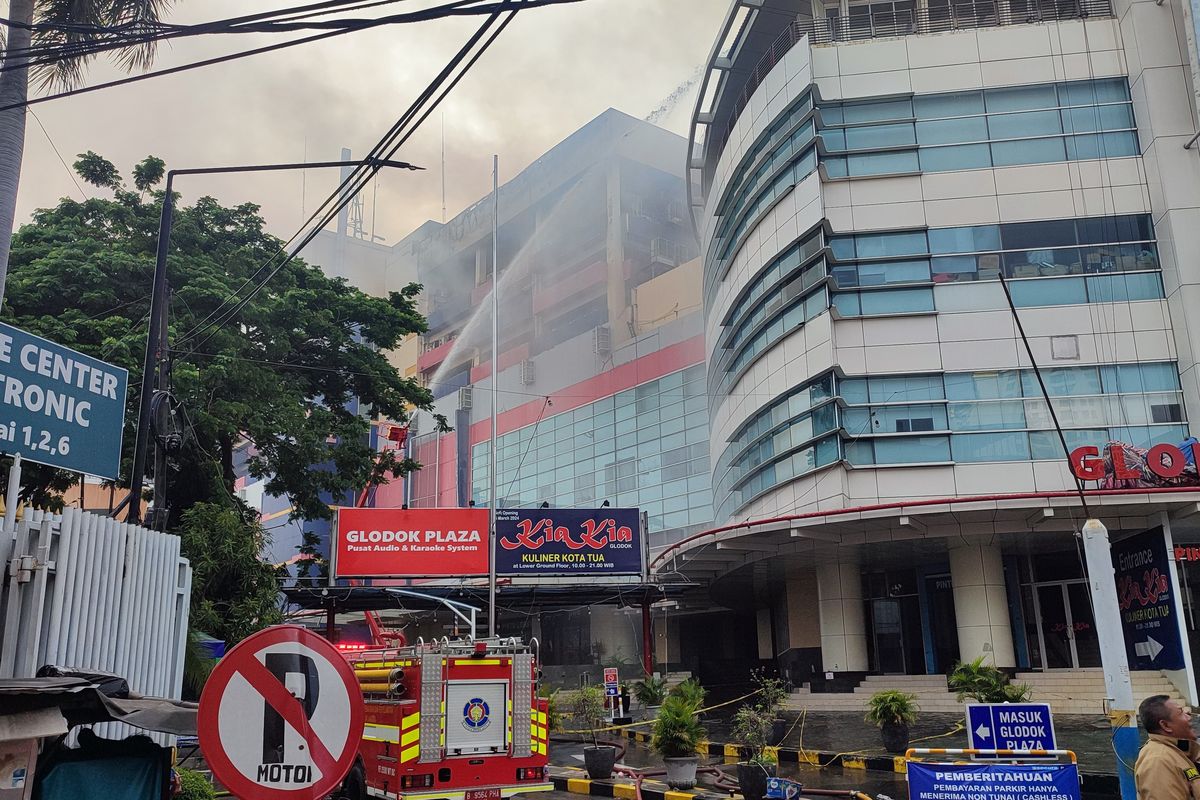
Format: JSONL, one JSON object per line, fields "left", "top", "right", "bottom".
{"left": 332, "top": 509, "right": 487, "bottom": 578}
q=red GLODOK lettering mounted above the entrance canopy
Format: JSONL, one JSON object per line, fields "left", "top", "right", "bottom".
{"left": 1070, "top": 438, "right": 1200, "bottom": 489}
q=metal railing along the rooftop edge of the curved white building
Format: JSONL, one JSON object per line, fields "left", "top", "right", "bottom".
{"left": 733, "top": 0, "right": 1112, "bottom": 118}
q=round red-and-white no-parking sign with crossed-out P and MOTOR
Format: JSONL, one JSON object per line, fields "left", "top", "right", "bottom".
{"left": 198, "top": 625, "right": 364, "bottom": 800}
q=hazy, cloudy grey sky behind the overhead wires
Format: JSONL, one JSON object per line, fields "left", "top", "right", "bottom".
{"left": 17, "top": 0, "right": 731, "bottom": 243}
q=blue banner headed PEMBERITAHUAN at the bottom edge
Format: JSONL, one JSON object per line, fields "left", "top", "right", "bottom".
{"left": 907, "top": 762, "right": 1080, "bottom": 800}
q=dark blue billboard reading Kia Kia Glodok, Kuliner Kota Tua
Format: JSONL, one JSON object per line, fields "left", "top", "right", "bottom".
{"left": 496, "top": 509, "right": 646, "bottom": 578}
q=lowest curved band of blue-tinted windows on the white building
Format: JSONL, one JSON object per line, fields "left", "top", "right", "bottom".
{"left": 713, "top": 361, "right": 1188, "bottom": 521}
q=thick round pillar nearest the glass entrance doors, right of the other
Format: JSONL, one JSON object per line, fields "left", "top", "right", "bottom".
{"left": 950, "top": 542, "right": 1016, "bottom": 667}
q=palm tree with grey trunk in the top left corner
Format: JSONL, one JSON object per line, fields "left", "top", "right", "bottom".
{"left": 0, "top": 0, "right": 170, "bottom": 303}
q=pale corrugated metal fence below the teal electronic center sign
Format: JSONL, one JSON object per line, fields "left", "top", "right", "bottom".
{"left": 0, "top": 509, "right": 192, "bottom": 744}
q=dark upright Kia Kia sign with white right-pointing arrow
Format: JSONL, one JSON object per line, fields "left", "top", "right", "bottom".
{"left": 1112, "top": 528, "right": 1186, "bottom": 669}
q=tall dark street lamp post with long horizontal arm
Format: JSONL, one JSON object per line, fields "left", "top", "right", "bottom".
{"left": 125, "top": 158, "right": 422, "bottom": 528}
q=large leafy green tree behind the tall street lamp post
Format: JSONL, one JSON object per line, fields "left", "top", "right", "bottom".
{"left": 5, "top": 152, "right": 432, "bottom": 524}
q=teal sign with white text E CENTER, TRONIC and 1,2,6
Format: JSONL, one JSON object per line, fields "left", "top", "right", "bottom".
{"left": 0, "top": 323, "right": 128, "bottom": 479}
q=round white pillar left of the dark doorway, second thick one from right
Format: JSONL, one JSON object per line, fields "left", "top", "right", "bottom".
{"left": 817, "top": 559, "right": 868, "bottom": 673}
